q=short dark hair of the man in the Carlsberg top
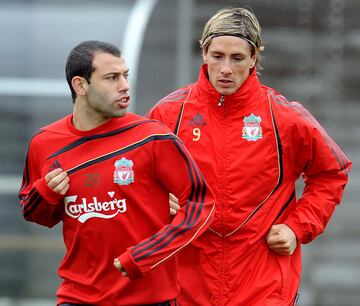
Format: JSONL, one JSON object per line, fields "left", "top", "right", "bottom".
{"left": 65, "top": 40, "right": 121, "bottom": 102}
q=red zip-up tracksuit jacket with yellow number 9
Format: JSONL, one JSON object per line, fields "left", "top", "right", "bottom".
{"left": 148, "top": 65, "right": 351, "bottom": 306}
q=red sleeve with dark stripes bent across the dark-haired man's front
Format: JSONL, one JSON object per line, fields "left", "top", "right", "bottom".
{"left": 120, "top": 136, "right": 215, "bottom": 278}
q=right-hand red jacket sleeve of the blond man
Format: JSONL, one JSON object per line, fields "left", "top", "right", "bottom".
{"left": 284, "top": 104, "right": 352, "bottom": 243}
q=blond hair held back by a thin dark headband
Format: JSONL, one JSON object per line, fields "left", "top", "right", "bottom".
{"left": 200, "top": 7, "right": 264, "bottom": 69}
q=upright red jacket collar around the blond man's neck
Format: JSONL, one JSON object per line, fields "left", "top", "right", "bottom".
{"left": 197, "top": 64, "right": 262, "bottom": 112}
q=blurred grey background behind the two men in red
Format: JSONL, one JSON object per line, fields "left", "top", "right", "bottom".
{"left": 0, "top": 0, "right": 360, "bottom": 306}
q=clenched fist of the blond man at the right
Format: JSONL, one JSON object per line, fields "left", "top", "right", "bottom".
{"left": 266, "top": 224, "right": 297, "bottom": 255}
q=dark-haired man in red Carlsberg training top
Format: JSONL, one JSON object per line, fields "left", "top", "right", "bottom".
{"left": 19, "top": 41, "right": 214, "bottom": 306}
